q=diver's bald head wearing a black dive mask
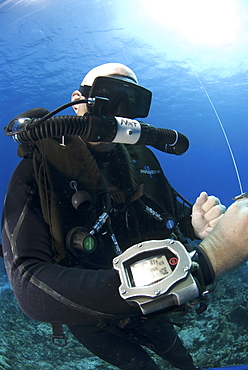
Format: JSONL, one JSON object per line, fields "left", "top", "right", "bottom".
{"left": 72, "top": 63, "right": 152, "bottom": 151}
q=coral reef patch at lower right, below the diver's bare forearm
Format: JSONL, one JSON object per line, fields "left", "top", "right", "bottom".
{"left": 170, "top": 265, "right": 248, "bottom": 367}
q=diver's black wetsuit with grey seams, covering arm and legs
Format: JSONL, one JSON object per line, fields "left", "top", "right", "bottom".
{"left": 3, "top": 142, "right": 202, "bottom": 370}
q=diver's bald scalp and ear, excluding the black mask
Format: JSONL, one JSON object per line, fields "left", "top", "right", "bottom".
{"left": 72, "top": 63, "right": 138, "bottom": 116}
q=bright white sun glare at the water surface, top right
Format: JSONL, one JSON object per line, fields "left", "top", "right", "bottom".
{"left": 142, "top": 0, "right": 240, "bottom": 46}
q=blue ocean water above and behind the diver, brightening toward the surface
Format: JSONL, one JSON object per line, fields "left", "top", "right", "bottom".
{"left": 0, "top": 0, "right": 248, "bottom": 214}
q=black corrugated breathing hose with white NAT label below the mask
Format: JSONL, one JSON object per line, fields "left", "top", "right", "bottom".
{"left": 4, "top": 97, "right": 189, "bottom": 155}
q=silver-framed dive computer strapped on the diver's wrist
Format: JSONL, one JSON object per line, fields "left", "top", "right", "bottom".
{"left": 113, "top": 239, "right": 200, "bottom": 315}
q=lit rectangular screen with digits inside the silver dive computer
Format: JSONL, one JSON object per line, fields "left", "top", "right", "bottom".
{"left": 130, "top": 254, "right": 172, "bottom": 287}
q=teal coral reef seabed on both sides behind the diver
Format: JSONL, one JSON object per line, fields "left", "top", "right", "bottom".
{"left": 0, "top": 259, "right": 248, "bottom": 370}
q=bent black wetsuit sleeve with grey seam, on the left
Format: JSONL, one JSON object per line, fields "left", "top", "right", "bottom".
{"left": 2, "top": 159, "right": 141, "bottom": 325}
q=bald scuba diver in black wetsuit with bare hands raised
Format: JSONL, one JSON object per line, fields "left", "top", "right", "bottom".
{"left": 2, "top": 63, "right": 248, "bottom": 370}
